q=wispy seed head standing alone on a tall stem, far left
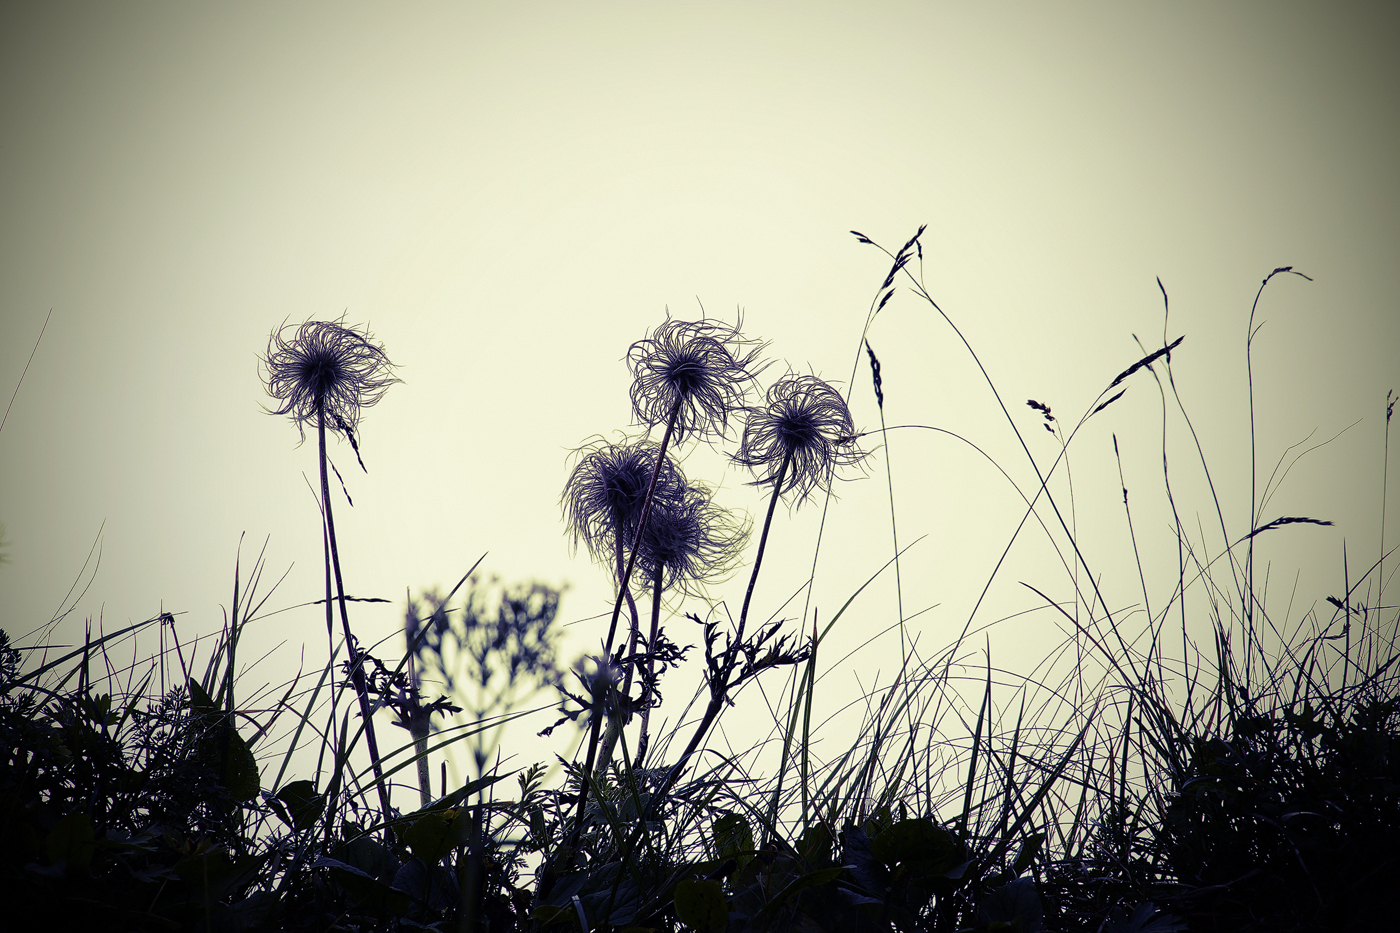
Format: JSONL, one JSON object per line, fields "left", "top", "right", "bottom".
{"left": 262, "top": 321, "right": 402, "bottom": 438}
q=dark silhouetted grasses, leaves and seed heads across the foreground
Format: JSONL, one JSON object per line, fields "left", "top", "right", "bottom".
{"left": 0, "top": 231, "right": 1400, "bottom": 933}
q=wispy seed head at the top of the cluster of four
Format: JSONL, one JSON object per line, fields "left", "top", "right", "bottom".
{"left": 627, "top": 318, "right": 767, "bottom": 443}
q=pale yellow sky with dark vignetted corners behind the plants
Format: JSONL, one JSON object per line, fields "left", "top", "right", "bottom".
{"left": 0, "top": 3, "right": 1400, "bottom": 784}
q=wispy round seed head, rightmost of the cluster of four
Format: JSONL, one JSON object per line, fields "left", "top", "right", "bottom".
{"left": 734, "top": 374, "right": 867, "bottom": 506}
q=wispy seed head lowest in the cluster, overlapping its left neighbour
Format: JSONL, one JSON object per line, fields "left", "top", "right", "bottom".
{"left": 637, "top": 483, "right": 749, "bottom": 595}
